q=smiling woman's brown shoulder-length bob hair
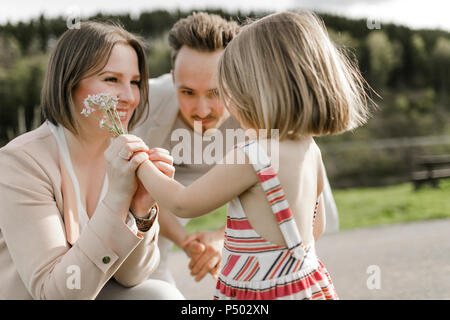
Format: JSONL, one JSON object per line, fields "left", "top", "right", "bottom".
{"left": 41, "top": 21, "right": 149, "bottom": 134}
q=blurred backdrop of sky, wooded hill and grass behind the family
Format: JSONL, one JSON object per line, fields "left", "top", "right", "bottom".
{"left": 0, "top": 0, "right": 450, "bottom": 236}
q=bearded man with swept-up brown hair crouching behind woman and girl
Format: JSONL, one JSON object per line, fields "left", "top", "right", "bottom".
{"left": 133, "top": 13, "right": 336, "bottom": 284}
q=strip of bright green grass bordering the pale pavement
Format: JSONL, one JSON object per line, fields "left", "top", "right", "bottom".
{"left": 187, "top": 179, "right": 450, "bottom": 233}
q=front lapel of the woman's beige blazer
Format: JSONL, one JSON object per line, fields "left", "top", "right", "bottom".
{"left": 58, "top": 154, "right": 80, "bottom": 246}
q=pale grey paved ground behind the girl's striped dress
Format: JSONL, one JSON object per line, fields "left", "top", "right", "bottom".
{"left": 170, "top": 219, "right": 450, "bottom": 299}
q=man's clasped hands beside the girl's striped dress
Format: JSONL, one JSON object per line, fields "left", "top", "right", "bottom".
{"left": 181, "top": 227, "right": 224, "bottom": 282}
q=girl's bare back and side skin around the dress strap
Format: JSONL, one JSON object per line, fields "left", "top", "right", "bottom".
{"left": 239, "top": 137, "right": 322, "bottom": 246}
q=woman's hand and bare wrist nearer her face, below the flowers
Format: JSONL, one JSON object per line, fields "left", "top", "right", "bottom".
{"left": 103, "top": 134, "right": 149, "bottom": 222}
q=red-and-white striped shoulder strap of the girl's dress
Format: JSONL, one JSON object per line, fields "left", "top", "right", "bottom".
{"left": 238, "top": 140, "right": 305, "bottom": 259}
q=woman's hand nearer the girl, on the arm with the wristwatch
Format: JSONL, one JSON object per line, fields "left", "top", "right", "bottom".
{"left": 130, "top": 148, "right": 175, "bottom": 218}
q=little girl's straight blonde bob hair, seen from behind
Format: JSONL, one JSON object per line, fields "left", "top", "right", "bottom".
{"left": 218, "top": 11, "right": 372, "bottom": 140}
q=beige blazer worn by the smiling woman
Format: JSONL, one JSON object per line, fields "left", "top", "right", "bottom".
{"left": 0, "top": 123, "right": 159, "bottom": 299}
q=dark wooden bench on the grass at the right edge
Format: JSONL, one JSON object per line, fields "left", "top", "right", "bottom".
{"left": 411, "top": 154, "right": 450, "bottom": 190}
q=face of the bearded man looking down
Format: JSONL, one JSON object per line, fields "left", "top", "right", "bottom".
{"left": 172, "top": 46, "right": 229, "bottom": 132}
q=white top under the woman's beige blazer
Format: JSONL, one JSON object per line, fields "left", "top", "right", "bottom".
{"left": 48, "top": 122, "right": 138, "bottom": 234}
